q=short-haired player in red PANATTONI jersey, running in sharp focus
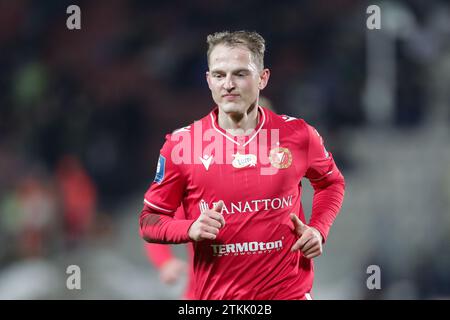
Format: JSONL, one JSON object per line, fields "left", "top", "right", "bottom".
{"left": 140, "top": 31, "right": 345, "bottom": 300}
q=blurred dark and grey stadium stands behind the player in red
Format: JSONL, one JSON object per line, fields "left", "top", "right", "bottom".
{"left": 0, "top": 0, "right": 450, "bottom": 299}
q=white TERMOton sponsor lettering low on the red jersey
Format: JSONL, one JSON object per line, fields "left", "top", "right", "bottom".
{"left": 211, "top": 240, "right": 283, "bottom": 257}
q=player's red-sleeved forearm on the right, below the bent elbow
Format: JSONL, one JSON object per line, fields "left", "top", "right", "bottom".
{"left": 308, "top": 174, "right": 345, "bottom": 242}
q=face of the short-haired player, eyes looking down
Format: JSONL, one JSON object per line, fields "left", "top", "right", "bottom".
{"left": 206, "top": 45, "right": 269, "bottom": 114}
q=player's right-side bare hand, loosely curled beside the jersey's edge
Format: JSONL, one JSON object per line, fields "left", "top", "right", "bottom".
{"left": 290, "top": 213, "right": 323, "bottom": 259}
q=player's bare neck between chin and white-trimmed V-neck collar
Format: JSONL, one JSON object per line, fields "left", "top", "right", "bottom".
{"left": 218, "top": 104, "right": 259, "bottom": 136}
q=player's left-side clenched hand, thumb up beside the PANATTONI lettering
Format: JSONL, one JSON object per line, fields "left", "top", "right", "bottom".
{"left": 188, "top": 200, "right": 225, "bottom": 241}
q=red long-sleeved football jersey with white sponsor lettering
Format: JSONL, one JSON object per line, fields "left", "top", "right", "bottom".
{"left": 140, "top": 107, "right": 345, "bottom": 299}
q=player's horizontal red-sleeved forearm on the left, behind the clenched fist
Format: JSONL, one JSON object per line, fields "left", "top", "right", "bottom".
{"left": 139, "top": 206, "right": 194, "bottom": 244}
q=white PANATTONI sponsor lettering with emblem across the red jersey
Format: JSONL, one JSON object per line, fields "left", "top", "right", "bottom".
{"left": 199, "top": 195, "right": 293, "bottom": 214}
